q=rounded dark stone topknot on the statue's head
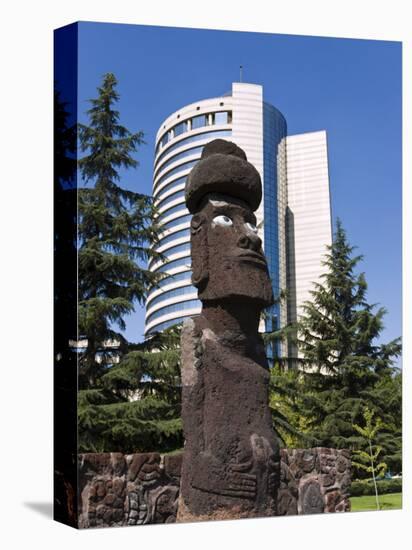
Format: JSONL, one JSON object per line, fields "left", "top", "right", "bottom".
{"left": 185, "top": 139, "right": 262, "bottom": 214}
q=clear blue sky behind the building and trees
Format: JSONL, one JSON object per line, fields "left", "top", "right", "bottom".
{"left": 78, "top": 23, "right": 402, "bottom": 350}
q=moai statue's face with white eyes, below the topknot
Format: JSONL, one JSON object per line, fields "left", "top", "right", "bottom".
{"left": 191, "top": 194, "right": 273, "bottom": 308}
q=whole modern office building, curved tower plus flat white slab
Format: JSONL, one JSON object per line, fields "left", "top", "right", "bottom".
{"left": 145, "top": 83, "right": 331, "bottom": 360}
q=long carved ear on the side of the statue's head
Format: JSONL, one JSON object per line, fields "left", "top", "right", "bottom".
{"left": 190, "top": 214, "right": 209, "bottom": 293}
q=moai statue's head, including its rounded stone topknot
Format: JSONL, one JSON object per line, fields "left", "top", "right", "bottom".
{"left": 186, "top": 139, "right": 273, "bottom": 308}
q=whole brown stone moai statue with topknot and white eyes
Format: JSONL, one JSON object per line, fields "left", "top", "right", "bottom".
{"left": 177, "top": 139, "right": 280, "bottom": 521}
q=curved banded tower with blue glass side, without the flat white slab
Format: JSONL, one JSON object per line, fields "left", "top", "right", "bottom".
{"left": 145, "top": 82, "right": 330, "bottom": 354}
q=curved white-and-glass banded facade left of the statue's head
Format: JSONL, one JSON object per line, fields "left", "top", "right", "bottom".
{"left": 146, "top": 98, "right": 238, "bottom": 335}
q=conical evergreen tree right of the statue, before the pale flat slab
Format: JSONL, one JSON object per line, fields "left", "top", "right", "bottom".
{"left": 298, "top": 221, "right": 401, "bottom": 460}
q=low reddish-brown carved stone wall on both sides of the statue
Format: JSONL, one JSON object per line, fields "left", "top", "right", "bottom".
{"left": 79, "top": 447, "right": 351, "bottom": 528}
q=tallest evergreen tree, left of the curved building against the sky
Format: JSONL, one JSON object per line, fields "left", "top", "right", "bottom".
{"left": 78, "top": 73, "right": 156, "bottom": 387}
